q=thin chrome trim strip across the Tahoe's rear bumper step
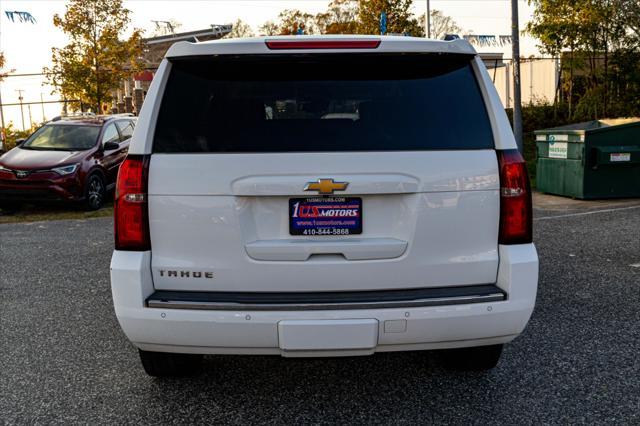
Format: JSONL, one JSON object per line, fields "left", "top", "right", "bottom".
{"left": 147, "top": 293, "right": 506, "bottom": 311}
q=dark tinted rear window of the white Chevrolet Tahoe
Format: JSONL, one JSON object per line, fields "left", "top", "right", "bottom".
{"left": 154, "top": 53, "right": 493, "bottom": 153}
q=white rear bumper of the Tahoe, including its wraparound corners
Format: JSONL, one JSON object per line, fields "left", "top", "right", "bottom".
{"left": 111, "top": 244, "right": 538, "bottom": 356}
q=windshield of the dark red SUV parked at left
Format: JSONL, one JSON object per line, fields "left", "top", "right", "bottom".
{"left": 22, "top": 124, "right": 100, "bottom": 151}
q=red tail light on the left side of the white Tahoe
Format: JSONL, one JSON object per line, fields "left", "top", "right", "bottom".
{"left": 114, "top": 155, "right": 151, "bottom": 251}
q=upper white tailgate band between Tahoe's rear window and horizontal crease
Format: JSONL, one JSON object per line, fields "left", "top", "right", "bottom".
{"left": 149, "top": 149, "right": 499, "bottom": 197}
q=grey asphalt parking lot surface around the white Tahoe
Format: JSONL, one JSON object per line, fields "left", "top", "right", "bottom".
{"left": 0, "top": 196, "right": 640, "bottom": 424}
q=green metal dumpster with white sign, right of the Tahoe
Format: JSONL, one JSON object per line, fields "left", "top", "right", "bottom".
{"left": 534, "top": 118, "right": 640, "bottom": 199}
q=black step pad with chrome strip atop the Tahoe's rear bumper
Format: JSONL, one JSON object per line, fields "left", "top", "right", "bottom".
{"left": 146, "top": 284, "right": 507, "bottom": 311}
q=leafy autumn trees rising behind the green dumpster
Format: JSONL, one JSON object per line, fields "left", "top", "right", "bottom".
{"left": 527, "top": 0, "right": 640, "bottom": 118}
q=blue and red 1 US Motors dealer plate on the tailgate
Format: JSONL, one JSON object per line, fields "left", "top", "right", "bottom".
{"left": 289, "top": 197, "right": 362, "bottom": 235}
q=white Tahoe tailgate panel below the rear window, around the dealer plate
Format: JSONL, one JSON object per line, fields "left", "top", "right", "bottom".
{"left": 149, "top": 150, "right": 500, "bottom": 292}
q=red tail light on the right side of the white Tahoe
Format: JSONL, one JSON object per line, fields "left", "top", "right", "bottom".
{"left": 498, "top": 149, "right": 533, "bottom": 244}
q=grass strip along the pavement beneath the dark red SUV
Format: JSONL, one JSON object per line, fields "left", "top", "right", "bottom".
{"left": 0, "top": 202, "right": 113, "bottom": 223}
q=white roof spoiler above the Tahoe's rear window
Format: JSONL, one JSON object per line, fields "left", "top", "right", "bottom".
{"left": 165, "top": 35, "right": 476, "bottom": 58}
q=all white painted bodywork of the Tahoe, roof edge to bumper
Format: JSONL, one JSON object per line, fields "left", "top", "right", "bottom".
{"left": 111, "top": 36, "right": 538, "bottom": 356}
